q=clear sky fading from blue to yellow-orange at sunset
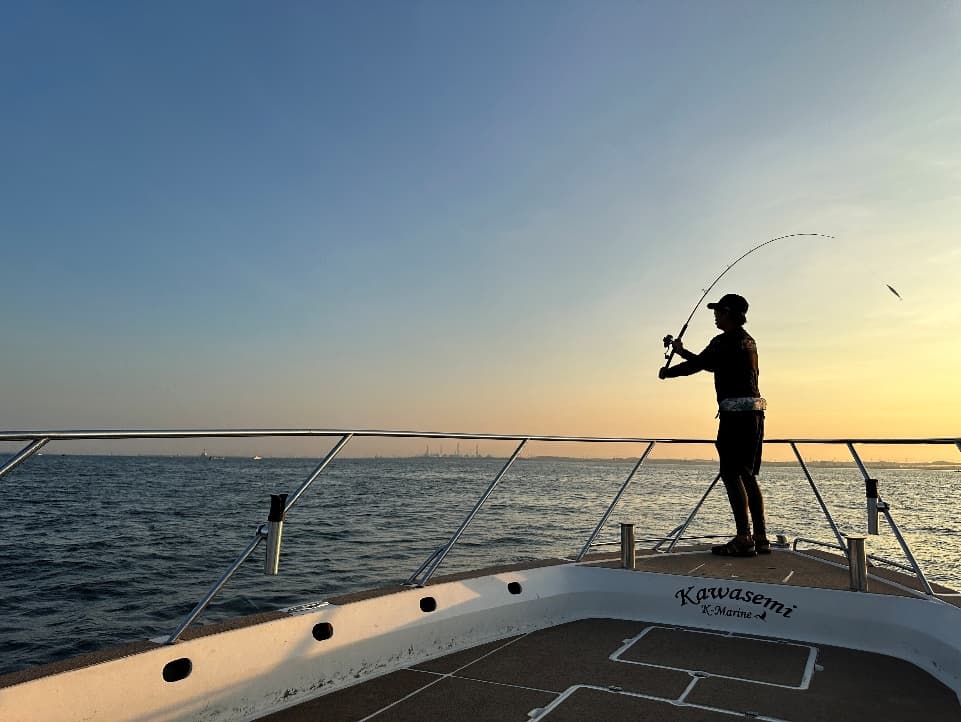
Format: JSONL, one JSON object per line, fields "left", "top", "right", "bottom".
{"left": 0, "top": 0, "right": 961, "bottom": 458}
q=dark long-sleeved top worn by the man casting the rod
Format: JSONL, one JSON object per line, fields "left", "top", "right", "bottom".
{"left": 666, "top": 326, "right": 761, "bottom": 403}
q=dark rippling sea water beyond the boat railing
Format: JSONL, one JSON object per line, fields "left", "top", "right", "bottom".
{"left": 0, "top": 455, "right": 961, "bottom": 673}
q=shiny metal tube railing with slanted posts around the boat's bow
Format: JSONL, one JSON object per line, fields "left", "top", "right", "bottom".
{"left": 0, "top": 429, "right": 961, "bottom": 644}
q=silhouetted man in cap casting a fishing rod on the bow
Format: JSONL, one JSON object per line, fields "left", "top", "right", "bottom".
{"left": 658, "top": 293, "right": 771, "bottom": 557}
